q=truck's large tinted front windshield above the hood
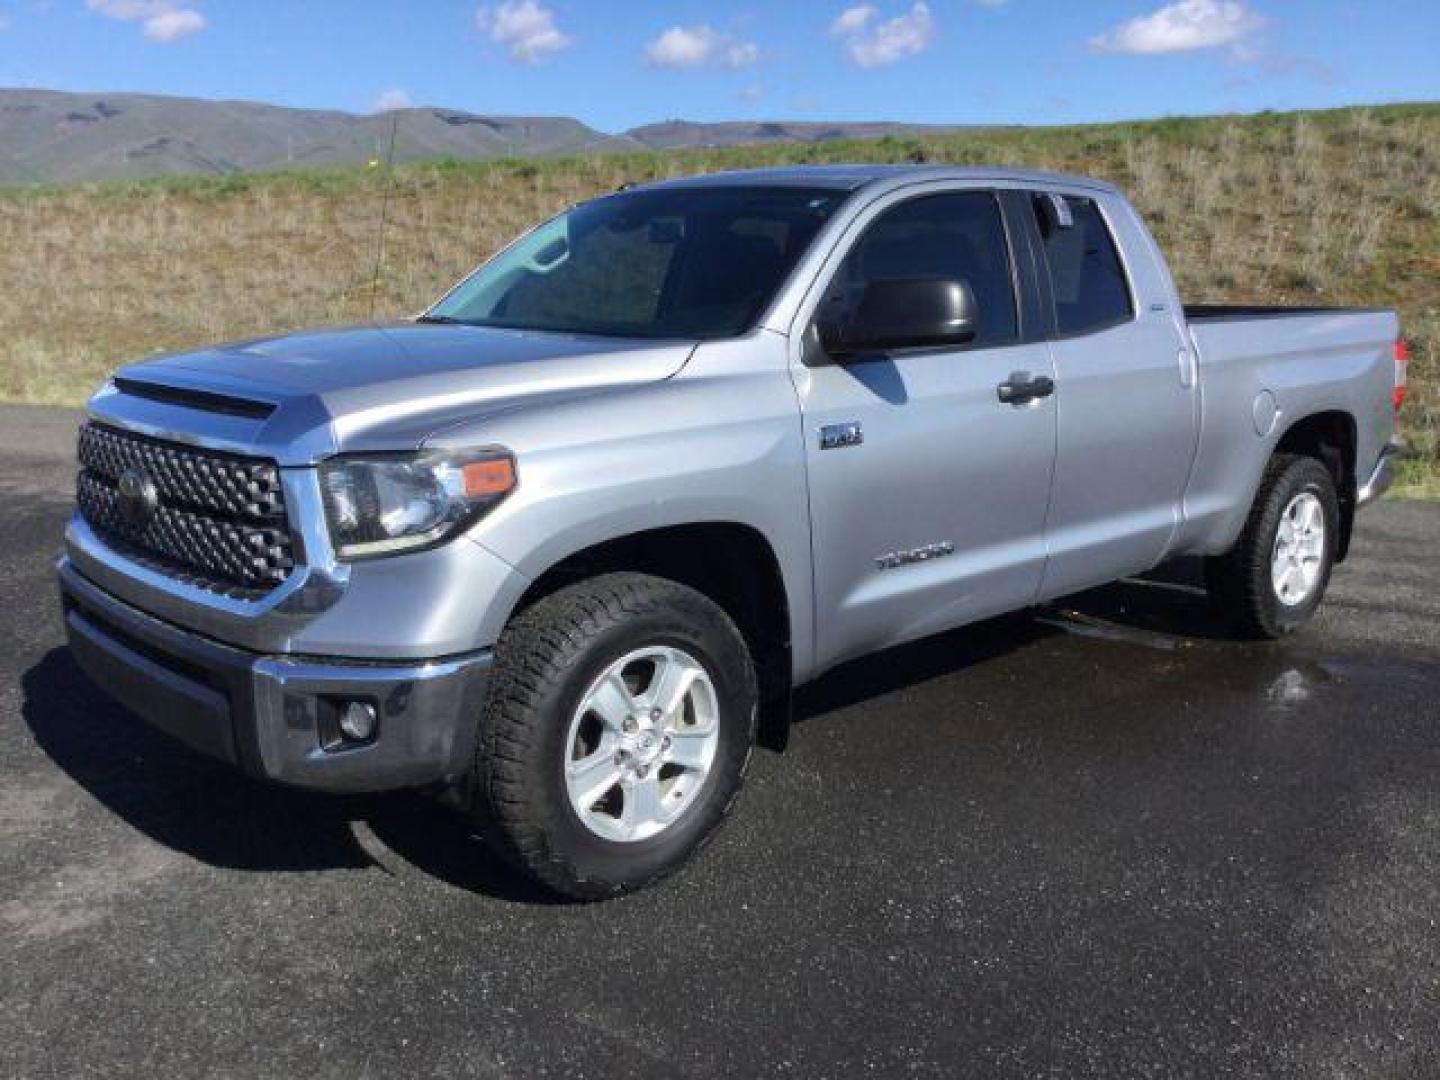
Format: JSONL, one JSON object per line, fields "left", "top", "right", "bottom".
{"left": 425, "top": 187, "right": 845, "bottom": 338}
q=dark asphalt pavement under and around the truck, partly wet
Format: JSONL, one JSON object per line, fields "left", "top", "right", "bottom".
{"left": 0, "top": 409, "right": 1440, "bottom": 1077}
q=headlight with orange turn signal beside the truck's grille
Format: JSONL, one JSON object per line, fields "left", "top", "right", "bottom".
{"left": 320, "top": 451, "right": 516, "bottom": 559}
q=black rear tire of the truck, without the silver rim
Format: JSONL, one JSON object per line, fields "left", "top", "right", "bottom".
{"left": 1205, "top": 454, "right": 1341, "bottom": 639}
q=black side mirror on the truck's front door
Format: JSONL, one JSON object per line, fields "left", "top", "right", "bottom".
{"left": 821, "top": 278, "right": 981, "bottom": 359}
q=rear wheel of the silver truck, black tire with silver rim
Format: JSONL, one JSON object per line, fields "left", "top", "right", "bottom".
{"left": 1205, "top": 454, "right": 1339, "bottom": 638}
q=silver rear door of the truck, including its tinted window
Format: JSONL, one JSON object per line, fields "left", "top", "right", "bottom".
{"left": 1031, "top": 192, "right": 1200, "bottom": 598}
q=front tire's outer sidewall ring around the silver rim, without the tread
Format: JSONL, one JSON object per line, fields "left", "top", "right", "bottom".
{"left": 528, "top": 590, "right": 755, "bottom": 883}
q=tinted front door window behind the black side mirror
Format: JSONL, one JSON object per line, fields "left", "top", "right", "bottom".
{"left": 816, "top": 192, "right": 1018, "bottom": 348}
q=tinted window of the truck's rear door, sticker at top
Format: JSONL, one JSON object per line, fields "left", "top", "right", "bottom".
{"left": 1034, "top": 194, "right": 1135, "bottom": 334}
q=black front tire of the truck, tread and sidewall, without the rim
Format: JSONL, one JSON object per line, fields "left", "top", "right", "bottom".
{"left": 472, "top": 573, "right": 757, "bottom": 900}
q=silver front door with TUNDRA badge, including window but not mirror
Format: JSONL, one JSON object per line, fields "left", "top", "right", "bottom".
{"left": 795, "top": 190, "right": 1056, "bottom": 667}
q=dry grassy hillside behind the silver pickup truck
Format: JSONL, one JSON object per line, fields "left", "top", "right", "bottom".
{"left": 0, "top": 105, "right": 1440, "bottom": 494}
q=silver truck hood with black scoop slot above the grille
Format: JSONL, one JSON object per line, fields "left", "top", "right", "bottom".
{"left": 89, "top": 323, "right": 696, "bottom": 465}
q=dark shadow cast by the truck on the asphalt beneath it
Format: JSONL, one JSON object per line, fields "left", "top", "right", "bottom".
{"left": 22, "top": 582, "right": 1238, "bottom": 903}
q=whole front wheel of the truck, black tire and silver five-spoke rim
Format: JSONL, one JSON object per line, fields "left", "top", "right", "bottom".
{"left": 474, "top": 573, "right": 756, "bottom": 899}
